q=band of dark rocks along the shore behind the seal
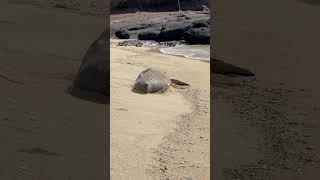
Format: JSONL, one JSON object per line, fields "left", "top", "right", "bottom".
{"left": 110, "top": 11, "right": 210, "bottom": 44}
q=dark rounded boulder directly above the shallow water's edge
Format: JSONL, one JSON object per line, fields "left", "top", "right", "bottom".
{"left": 184, "top": 27, "right": 210, "bottom": 44}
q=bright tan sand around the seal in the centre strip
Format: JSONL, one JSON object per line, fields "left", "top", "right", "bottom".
{"left": 110, "top": 40, "right": 210, "bottom": 179}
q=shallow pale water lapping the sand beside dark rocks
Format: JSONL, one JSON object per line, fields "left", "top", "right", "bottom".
{"left": 160, "top": 45, "right": 210, "bottom": 61}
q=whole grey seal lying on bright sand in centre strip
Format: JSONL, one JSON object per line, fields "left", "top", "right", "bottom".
{"left": 133, "top": 68, "right": 190, "bottom": 93}
